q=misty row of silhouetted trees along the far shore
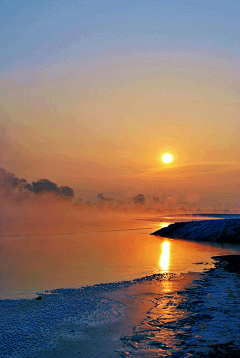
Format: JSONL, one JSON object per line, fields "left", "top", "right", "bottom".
{"left": 0, "top": 168, "right": 231, "bottom": 213}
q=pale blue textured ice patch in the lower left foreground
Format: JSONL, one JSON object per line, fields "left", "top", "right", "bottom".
{"left": 0, "top": 289, "right": 124, "bottom": 358}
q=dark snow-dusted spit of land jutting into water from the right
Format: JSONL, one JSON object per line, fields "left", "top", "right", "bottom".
{"left": 151, "top": 219, "right": 240, "bottom": 244}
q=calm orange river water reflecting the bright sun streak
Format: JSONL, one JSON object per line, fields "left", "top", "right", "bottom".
{"left": 0, "top": 216, "right": 240, "bottom": 298}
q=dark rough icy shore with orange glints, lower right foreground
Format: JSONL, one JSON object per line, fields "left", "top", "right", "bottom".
{"left": 118, "top": 256, "right": 240, "bottom": 358}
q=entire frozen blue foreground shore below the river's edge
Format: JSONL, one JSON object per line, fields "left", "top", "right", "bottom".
{"left": 0, "top": 255, "right": 240, "bottom": 358}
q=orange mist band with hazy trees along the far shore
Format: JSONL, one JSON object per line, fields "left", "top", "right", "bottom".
{"left": 0, "top": 169, "right": 240, "bottom": 236}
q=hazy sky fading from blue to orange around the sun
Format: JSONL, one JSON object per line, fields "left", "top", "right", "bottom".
{"left": 0, "top": 0, "right": 240, "bottom": 210}
